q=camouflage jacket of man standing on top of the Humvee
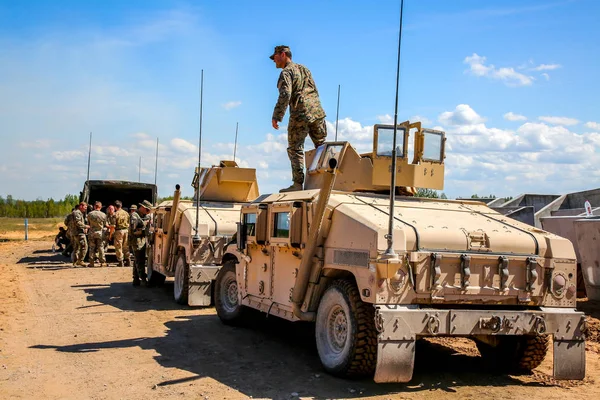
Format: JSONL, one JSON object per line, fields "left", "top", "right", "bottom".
{"left": 273, "top": 61, "right": 325, "bottom": 122}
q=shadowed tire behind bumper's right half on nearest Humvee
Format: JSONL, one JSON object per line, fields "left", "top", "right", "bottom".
{"left": 475, "top": 335, "right": 550, "bottom": 372}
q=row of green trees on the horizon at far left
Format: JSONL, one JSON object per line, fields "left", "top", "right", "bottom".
{"left": 0, "top": 194, "right": 79, "bottom": 218}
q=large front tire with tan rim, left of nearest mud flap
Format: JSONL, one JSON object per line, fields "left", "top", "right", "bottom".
{"left": 315, "top": 280, "right": 377, "bottom": 378}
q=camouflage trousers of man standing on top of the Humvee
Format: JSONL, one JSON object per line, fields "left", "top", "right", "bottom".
{"left": 288, "top": 118, "right": 327, "bottom": 185}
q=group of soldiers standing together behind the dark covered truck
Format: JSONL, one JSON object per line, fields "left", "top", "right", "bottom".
{"left": 65, "top": 200, "right": 153, "bottom": 286}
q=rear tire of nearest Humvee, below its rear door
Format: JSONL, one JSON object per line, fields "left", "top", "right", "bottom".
{"left": 214, "top": 260, "right": 248, "bottom": 325}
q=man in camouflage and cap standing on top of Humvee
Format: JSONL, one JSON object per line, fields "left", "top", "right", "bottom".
{"left": 269, "top": 45, "right": 327, "bottom": 192}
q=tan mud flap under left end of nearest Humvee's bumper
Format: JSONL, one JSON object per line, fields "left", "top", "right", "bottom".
{"left": 375, "top": 339, "right": 415, "bottom": 383}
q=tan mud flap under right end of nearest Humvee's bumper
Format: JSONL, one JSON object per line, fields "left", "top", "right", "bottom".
{"left": 553, "top": 338, "right": 585, "bottom": 379}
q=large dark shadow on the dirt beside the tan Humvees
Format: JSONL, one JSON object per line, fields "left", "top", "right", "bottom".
{"left": 32, "top": 283, "right": 548, "bottom": 399}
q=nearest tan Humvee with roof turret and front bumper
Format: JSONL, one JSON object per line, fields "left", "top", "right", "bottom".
{"left": 215, "top": 122, "right": 586, "bottom": 382}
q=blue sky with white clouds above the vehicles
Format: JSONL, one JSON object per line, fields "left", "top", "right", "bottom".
{"left": 0, "top": 0, "right": 600, "bottom": 199}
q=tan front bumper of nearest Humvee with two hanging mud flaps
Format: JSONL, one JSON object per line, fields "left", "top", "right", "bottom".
{"left": 375, "top": 305, "right": 586, "bottom": 382}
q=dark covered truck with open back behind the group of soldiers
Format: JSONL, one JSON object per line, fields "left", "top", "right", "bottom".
{"left": 79, "top": 180, "right": 157, "bottom": 207}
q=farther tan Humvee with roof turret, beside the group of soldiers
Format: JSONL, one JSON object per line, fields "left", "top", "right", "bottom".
{"left": 147, "top": 161, "right": 258, "bottom": 306}
